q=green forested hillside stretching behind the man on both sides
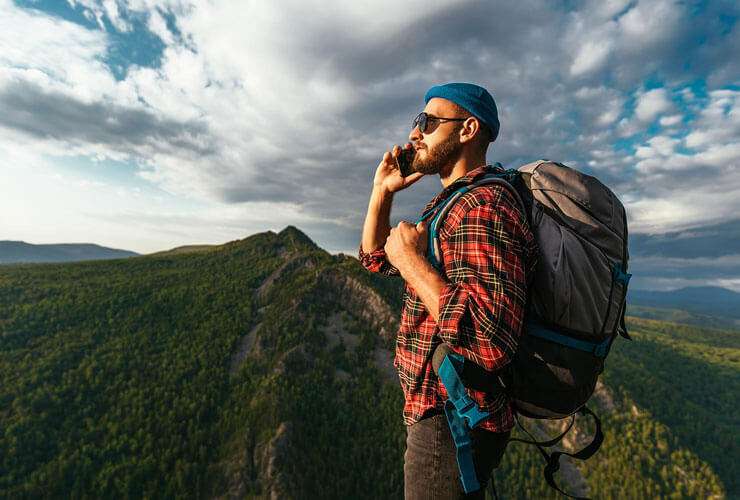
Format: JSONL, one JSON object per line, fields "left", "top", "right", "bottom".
{"left": 0, "top": 227, "right": 740, "bottom": 498}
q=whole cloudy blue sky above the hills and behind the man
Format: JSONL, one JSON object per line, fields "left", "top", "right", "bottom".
{"left": 0, "top": 0, "right": 740, "bottom": 291}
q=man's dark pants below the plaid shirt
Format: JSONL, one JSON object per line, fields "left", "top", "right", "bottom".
{"left": 403, "top": 415, "right": 511, "bottom": 500}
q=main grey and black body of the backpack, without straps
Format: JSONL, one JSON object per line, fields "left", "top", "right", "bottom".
{"left": 506, "top": 160, "right": 631, "bottom": 418}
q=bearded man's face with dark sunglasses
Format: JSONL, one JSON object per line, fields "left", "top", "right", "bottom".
{"left": 409, "top": 97, "right": 462, "bottom": 174}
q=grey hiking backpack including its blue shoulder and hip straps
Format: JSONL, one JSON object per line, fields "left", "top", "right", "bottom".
{"left": 421, "top": 160, "right": 631, "bottom": 496}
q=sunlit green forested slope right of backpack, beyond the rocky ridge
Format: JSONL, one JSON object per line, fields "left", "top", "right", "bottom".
{"left": 604, "top": 318, "right": 740, "bottom": 498}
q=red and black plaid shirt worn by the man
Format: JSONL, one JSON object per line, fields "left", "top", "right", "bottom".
{"left": 359, "top": 165, "right": 537, "bottom": 432}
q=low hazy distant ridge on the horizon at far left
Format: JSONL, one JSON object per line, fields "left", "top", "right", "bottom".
{"left": 0, "top": 241, "right": 138, "bottom": 264}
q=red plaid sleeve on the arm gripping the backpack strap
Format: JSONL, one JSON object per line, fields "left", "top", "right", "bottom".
{"left": 438, "top": 196, "right": 531, "bottom": 371}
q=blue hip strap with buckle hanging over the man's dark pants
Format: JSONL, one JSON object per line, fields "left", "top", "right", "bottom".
{"left": 435, "top": 350, "right": 490, "bottom": 493}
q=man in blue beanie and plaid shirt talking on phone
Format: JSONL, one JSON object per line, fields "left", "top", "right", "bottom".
{"left": 359, "top": 83, "right": 536, "bottom": 499}
